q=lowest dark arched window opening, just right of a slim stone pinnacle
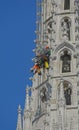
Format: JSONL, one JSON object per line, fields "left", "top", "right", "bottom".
{"left": 63, "top": 81, "right": 72, "bottom": 105}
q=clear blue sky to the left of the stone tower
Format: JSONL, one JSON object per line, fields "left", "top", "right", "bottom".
{"left": 0, "top": 0, "right": 36, "bottom": 130}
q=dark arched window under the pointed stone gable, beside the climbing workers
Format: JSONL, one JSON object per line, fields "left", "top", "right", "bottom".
{"left": 61, "top": 50, "right": 71, "bottom": 73}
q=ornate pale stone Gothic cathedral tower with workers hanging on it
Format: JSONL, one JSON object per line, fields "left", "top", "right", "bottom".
{"left": 18, "top": 0, "right": 79, "bottom": 130}
